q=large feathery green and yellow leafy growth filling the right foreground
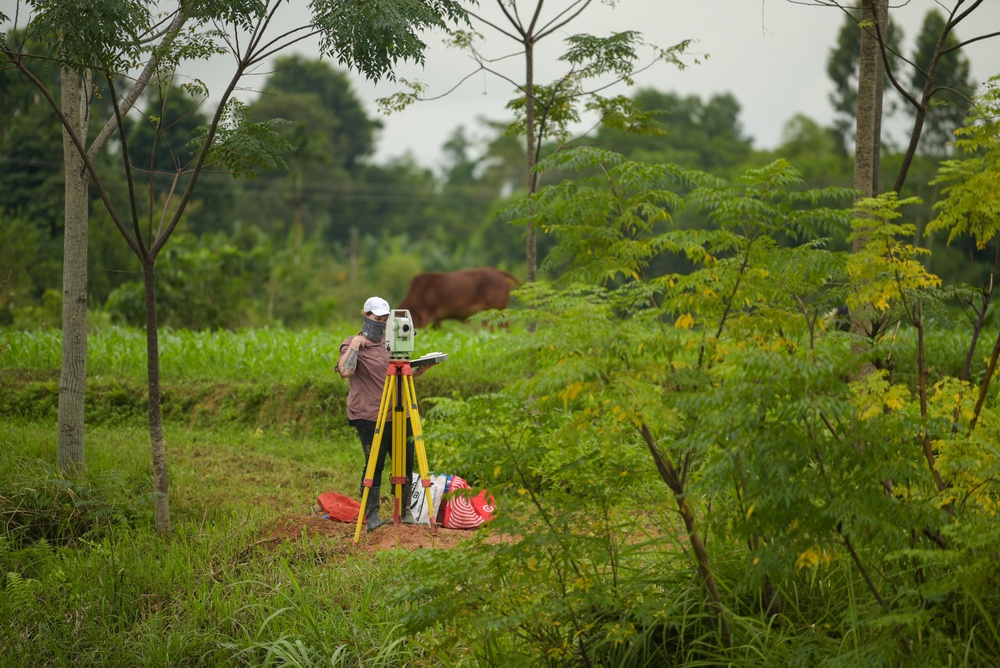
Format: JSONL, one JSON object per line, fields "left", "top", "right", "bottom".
{"left": 404, "top": 144, "right": 1000, "bottom": 665}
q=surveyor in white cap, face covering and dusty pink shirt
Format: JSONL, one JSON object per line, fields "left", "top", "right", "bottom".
{"left": 337, "top": 297, "right": 427, "bottom": 531}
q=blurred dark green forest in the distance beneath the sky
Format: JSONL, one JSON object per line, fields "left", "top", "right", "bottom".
{"left": 0, "top": 11, "right": 977, "bottom": 329}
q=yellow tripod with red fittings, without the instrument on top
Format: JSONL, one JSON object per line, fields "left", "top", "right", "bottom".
{"left": 354, "top": 359, "right": 435, "bottom": 543}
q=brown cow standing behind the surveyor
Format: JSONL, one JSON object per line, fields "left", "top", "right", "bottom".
{"left": 395, "top": 267, "right": 521, "bottom": 327}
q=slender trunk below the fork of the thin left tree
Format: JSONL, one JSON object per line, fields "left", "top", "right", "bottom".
{"left": 142, "top": 257, "right": 170, "bottom": 534}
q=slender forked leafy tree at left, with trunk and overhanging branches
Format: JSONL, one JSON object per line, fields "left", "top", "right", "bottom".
{"left": 0, "top": 0, "right": 464, "bottom": 532}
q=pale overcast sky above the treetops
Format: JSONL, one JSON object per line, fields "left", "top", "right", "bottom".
{"left": 0, "top": 0, "right": 1000, "bottom": 172}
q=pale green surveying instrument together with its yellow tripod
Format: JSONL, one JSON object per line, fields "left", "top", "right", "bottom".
{"left": 354, "top": 309, "right": 448, "bottom": 543}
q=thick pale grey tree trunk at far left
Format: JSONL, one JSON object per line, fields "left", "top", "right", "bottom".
{"left": 56, "top": 68, "right": 89, "bottom": 474}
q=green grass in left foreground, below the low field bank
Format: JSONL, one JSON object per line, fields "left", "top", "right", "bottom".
{"left": 0, "top": 420, "right": 446, "bottom": 666}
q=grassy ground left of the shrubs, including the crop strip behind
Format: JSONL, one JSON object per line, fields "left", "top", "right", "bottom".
{"left": 0, "top": 328, "right": 524, "bottom": 666}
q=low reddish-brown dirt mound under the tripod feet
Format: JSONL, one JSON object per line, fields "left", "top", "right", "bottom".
{"left": 257, "top": 515, "right": 475, "bottom": 552}
